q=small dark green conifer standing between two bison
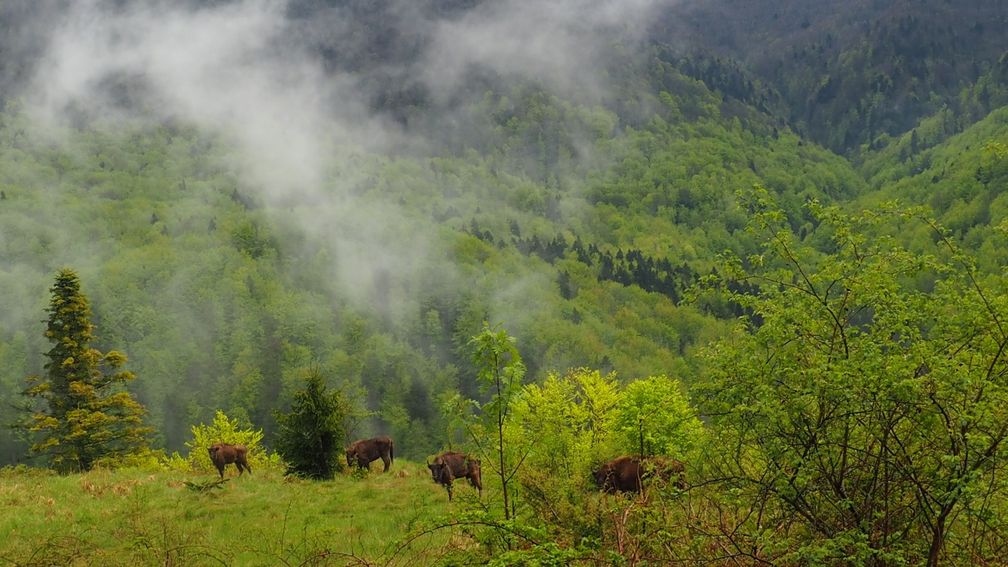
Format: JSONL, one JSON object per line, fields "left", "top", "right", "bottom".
{"left": 274, "top": 368, "right": 350, "bottom": 479}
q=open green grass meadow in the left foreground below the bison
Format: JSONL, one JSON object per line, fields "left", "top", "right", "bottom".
{"left": 0, "top": 461, "right": 483, "bottom": 566}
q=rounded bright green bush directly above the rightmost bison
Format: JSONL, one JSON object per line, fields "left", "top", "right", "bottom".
{"left": 614, "top": 376, "right": 705, "bottom": 459}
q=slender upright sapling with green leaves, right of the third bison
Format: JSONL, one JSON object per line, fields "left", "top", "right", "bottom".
{"left": 471, "top": 323, "right": 525, "bottom": 520}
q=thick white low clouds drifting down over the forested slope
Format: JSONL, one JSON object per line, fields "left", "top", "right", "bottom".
{"left": 13, "top": 0, "right": 662, "bottom": 314}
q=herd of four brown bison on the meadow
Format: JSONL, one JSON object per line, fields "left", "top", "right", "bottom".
{"left": 209, "top": 436, "right": 685, "bottom": 500}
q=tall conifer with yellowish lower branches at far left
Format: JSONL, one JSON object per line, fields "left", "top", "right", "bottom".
{"left": 24, "top": 269, "right": 150, "bottom": 471}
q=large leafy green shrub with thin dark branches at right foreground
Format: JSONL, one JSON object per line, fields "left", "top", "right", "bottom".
{"left": 698, "top": 191, "right": 1008, "bottom": 565}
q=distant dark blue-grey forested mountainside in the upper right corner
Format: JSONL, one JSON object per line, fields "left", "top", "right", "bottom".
{"left": 654, "top": 0, "right": 1008, "bottom": 154}
